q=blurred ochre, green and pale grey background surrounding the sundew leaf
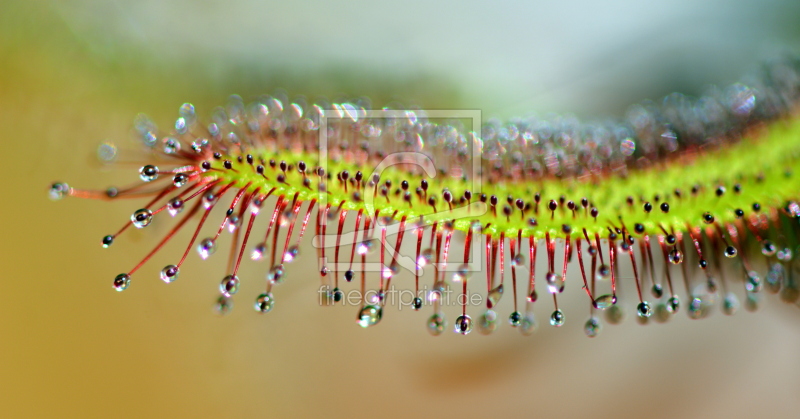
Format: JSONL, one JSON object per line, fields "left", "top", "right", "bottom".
{"left": 0, "top": 0, "right": 800, "bottom": 418}
